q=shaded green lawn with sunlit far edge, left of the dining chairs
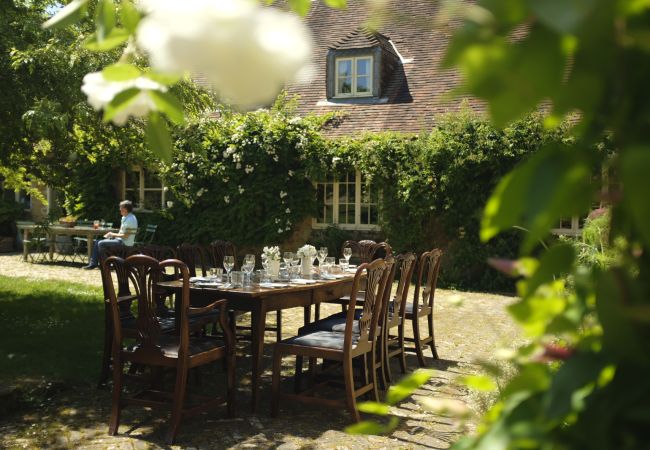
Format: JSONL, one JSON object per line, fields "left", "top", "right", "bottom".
{"left": 0, "top": 276, "right": 104, "bottom": 384}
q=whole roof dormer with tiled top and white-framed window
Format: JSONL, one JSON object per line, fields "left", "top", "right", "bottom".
{"left": 327, "top": 27, "right": 400, "bottom": 101}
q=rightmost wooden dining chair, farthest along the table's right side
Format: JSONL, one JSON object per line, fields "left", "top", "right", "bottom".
{"left": 404, "top": 248, "right": 442, "bottom": 367}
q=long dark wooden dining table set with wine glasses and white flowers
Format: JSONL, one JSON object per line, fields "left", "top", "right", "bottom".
{"left": 159, "top": 274, "right": 354, "bottom": 412}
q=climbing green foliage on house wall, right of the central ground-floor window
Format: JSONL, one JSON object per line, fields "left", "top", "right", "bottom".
{"left": 307, "top": 112, "right": 570, "bottom": 291}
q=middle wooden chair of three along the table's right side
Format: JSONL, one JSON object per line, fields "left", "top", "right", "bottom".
{"left": 383, "top": 253, "right": 417, "bottom": 383}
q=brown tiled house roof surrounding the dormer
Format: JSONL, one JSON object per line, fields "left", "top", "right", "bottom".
{"left": 287, "top": 0, "right": 484, "bottom": 135}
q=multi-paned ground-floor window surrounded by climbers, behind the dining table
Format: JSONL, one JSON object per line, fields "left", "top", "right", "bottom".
{"left": 312, "top": 171, "right": 379, "bottom": 230}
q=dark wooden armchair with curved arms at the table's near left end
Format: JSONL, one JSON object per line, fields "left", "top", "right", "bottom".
{"left": 105, "top": 255, "right": 235, "bottom": 445}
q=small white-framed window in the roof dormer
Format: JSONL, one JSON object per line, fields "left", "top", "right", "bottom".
{"left": 334, "top": 55, "right": 373, "bottom": 97}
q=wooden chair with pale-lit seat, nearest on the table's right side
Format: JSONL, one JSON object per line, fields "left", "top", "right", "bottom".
{"left": 271, "top": 259, "right": 389, "bottom": 422}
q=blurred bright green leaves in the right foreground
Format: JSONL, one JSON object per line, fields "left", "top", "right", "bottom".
{"left": 446, "top": 0, "right": 650, "bottom": 450}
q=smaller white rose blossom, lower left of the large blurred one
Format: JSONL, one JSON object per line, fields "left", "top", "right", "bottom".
{"left": 81, "top": 72, "right": 167, "bottom": 126}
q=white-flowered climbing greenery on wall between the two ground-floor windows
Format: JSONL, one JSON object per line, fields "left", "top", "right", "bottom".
{"left": 156, "top": 103, "right": 323, "bottom": 246}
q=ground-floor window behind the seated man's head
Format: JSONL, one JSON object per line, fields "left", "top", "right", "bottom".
{"left": 122, "top": 167, "right": 168, "bottom": 211}
